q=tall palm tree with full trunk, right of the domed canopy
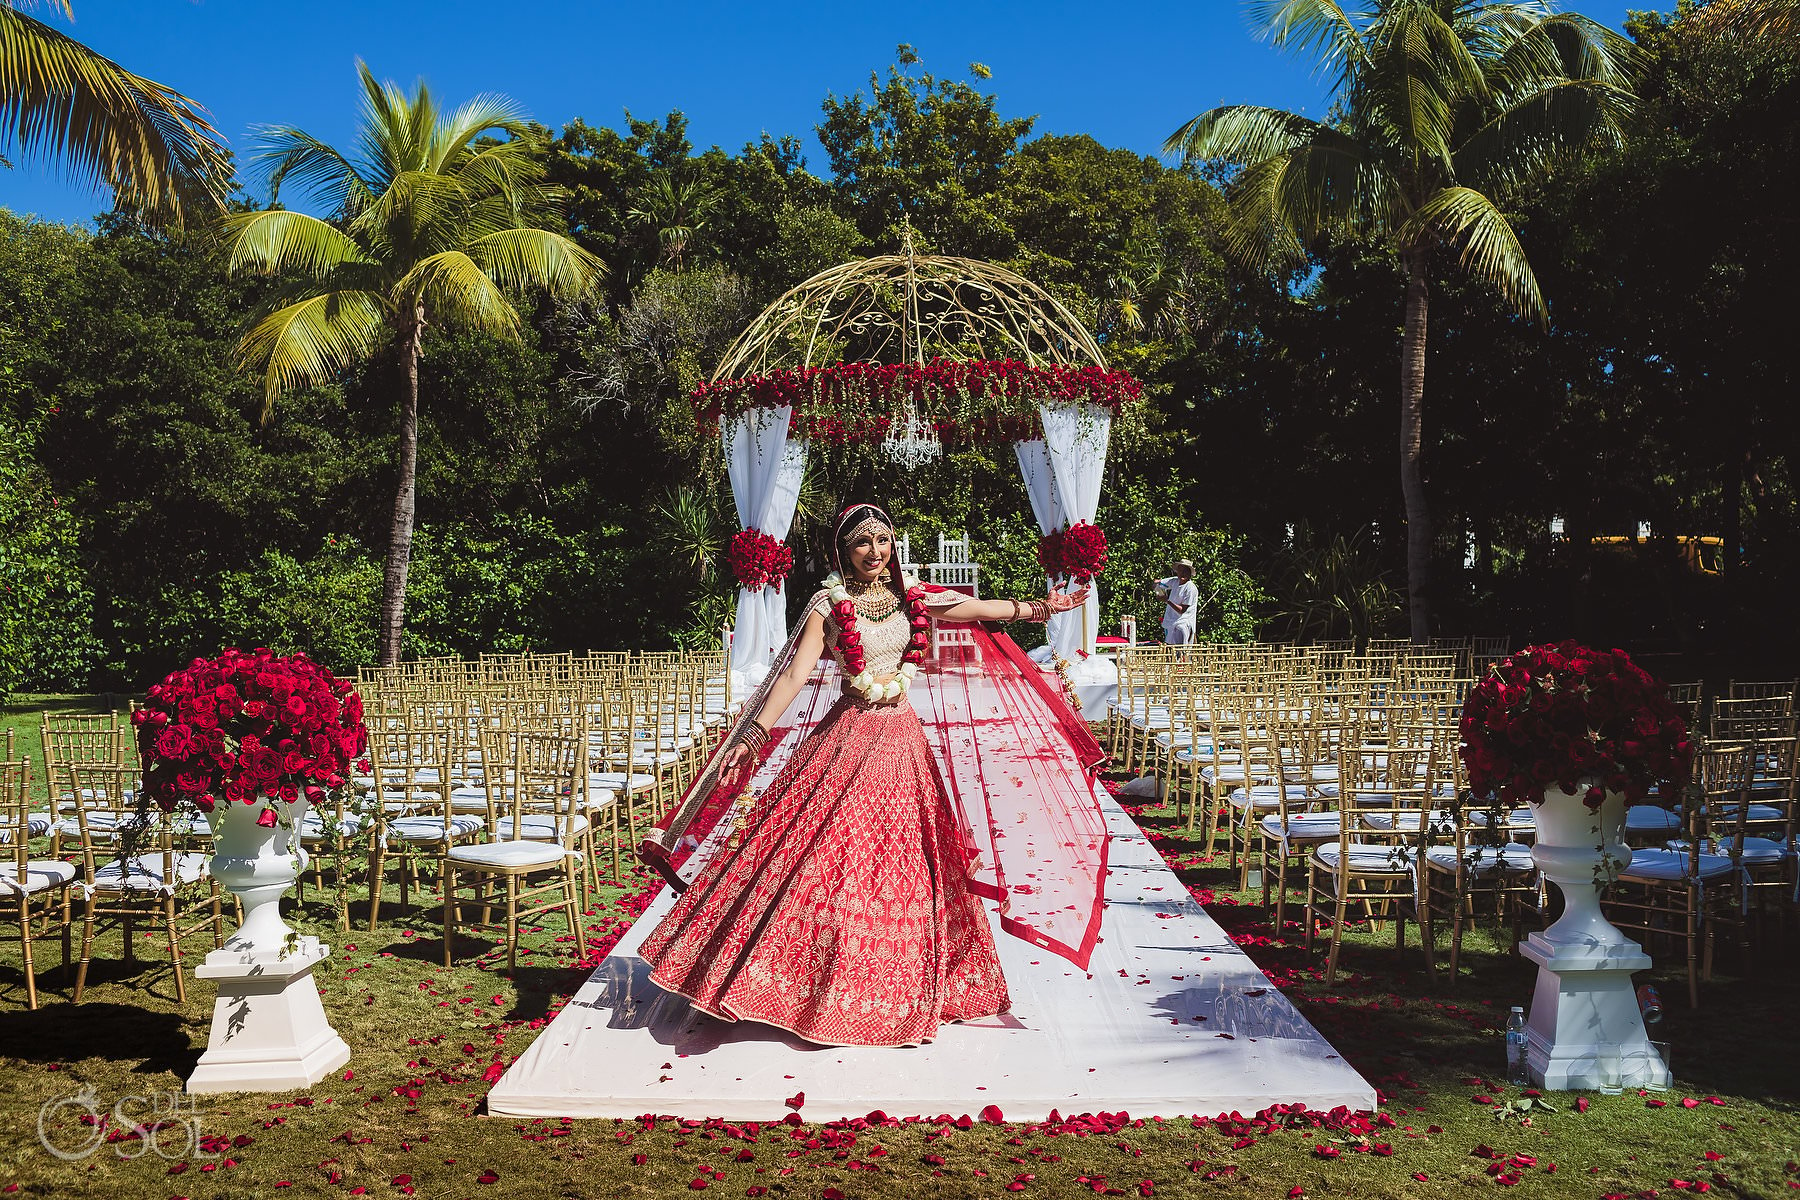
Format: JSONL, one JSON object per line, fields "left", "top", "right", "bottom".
{"left": 1165, "top": 0, "right": 1633, "bottom": 640}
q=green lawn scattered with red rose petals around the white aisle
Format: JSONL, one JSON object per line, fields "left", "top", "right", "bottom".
{"left": 0, "top": 712, "right": 1800, "bottom": 1200}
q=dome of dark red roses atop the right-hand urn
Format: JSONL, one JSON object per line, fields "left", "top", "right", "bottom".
{"left": 1462, "top": 640, "right": 1694, "bottom": 810}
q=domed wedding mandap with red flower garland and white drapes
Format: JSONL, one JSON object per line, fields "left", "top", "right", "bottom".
{"left": 691, "top": 230, "right": 1143, "bottom": 684}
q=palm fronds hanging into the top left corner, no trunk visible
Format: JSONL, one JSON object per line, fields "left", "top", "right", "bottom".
{"left": 0, "top": 0, "right": 232, "bottom": 221}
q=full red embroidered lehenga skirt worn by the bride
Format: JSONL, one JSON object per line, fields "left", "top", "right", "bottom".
{"left": 641, "top": 698, "right": 1010, "bottom": 1045}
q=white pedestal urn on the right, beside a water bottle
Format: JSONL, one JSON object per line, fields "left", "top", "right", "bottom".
{"left": 1521, "top": 779, "right": 1669, "bottom": 1088}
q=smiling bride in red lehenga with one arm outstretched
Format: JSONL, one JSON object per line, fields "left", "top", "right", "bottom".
{"left": 641, "top": 504, "right": 1087, "bottom": 1045}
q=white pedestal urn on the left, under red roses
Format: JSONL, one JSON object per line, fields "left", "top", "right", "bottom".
{"left": 187, "top": 799, "right": 349, "bottom": 1092}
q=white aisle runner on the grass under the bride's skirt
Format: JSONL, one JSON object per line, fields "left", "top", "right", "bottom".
{"left": 488, "top": 658, "right": 1375, "bottom": 1121}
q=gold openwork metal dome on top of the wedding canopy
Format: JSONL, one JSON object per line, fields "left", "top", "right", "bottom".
{"left": 713, "top": 228, "right": 1105, "bottom": 383}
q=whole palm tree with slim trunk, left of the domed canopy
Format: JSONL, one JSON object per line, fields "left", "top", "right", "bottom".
{"left": 225, "top": 63, "right": 605, "bottom": 664}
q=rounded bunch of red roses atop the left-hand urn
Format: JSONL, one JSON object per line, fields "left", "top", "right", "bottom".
{"left": 131, "top": 649, "right": 369, "bottom": 824}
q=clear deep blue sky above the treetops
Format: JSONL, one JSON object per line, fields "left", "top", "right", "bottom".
{"left": 0, "top": 0, "right": 1660, "bottom": 221}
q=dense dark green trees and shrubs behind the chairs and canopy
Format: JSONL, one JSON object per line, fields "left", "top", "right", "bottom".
{"left": 0, "top": 14, "right": 1800, "bottom": 689}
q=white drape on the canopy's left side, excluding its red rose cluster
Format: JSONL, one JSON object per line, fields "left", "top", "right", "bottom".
{"left": 722, "top": 407, "right": 806, "bottom": 685}
